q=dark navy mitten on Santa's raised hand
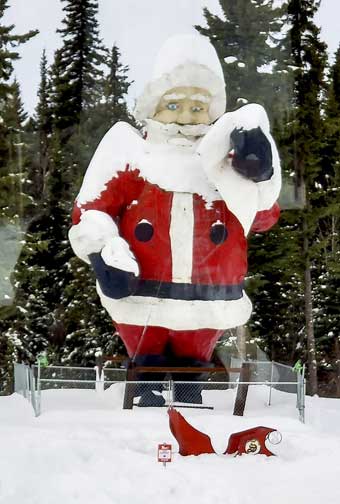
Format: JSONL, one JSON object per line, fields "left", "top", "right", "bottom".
{"left": 230, "top": 127, "right": 273, "bottom": 182}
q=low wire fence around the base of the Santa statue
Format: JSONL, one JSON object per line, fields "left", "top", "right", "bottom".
{"left": 14, "top": 362, "right": 305, "bottom": 422}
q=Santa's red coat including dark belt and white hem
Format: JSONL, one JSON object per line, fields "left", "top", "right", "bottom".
{"left": 73, "top": 165, "right": 278, "bottom": 329}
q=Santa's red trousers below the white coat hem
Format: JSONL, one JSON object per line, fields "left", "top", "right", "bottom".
{"left": 116, "top": 324, "right": 224, "bottom": 361}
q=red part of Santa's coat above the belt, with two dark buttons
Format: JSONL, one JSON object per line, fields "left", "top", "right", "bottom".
{"left": 73, "top": 168, "right": 247, "bottom": 285}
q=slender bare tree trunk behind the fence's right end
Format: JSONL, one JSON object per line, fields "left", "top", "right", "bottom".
{"left": 303, "top": 222, "right": 318, "bottom": 395}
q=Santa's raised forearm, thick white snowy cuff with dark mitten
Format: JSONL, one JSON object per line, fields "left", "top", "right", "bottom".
{"left": 197, "top": 104, "right": 281, "bottom": 234}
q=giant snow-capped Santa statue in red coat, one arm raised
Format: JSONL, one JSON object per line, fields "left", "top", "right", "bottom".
{"left": 69, "top": 35, "right": 281, "bottom": 405}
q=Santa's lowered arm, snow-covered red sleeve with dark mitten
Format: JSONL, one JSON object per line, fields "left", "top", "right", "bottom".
{"left": 69, "top": 125, "right": 144, "bottom": 297}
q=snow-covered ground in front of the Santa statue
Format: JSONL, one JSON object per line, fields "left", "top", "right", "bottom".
{"left": 0, "top": 384, "right": 340, "bottom": 504}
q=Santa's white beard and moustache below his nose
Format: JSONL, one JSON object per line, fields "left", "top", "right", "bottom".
{"left": 145, "top": 119, "right": 211, "bottom": 147}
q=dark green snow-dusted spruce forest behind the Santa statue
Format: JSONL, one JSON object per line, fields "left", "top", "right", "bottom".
{"left": 0, "top": 0, "right": 340, "bottom": 393}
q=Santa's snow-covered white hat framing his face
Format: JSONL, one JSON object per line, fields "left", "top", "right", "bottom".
{"left": 134, "top": 35, "right": 226, "bottom": 121}
